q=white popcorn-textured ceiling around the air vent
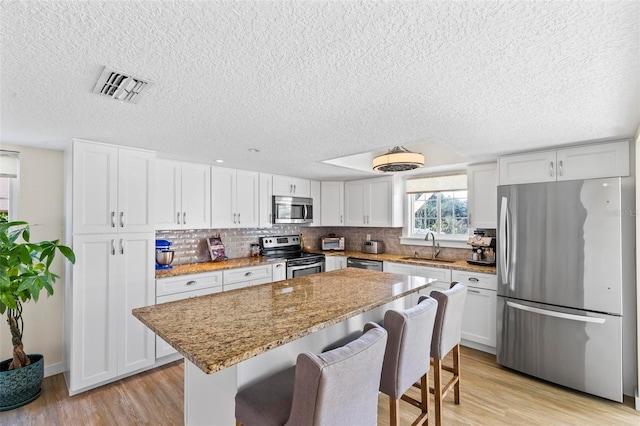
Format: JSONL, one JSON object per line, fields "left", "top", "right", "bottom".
{"left": 0, "top": 1, "right": 640, "bottom": 179}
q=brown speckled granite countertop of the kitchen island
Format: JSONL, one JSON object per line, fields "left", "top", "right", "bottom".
{"left": 133, "top": 268, "right": 435, "bottom": 374}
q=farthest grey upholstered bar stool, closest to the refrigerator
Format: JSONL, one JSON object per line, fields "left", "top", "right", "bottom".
{"left": 421, "top": 282, "right": 467, "bottom": 426}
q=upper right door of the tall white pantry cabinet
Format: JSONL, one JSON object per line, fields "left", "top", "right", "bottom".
{"left": 117, "top": 148, "right": 156, "bottom": 232}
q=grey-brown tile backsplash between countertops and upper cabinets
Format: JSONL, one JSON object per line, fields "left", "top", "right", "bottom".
{"left": 156, "top": 225, "right": 471, "bottom": 265}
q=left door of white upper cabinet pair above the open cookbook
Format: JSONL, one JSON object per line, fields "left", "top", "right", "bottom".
{"left": 211, "top": 167, "right": 238, "bottom": 228}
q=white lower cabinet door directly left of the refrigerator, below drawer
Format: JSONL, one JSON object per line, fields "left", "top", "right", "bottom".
{"left": 460, "top": 287, "right": 497, "bottom": 348}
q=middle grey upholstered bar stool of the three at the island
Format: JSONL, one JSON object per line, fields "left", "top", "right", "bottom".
{"left": 380, "top": 297, "right": 438, "bottom": 426}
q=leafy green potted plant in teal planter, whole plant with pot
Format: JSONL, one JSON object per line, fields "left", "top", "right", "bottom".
{"left": 0, "top": 222, "right": 75, "bottom": 411}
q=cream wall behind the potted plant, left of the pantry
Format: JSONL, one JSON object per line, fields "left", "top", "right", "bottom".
{"left": 0, "top": 144, "right": 64, "bottom": 375}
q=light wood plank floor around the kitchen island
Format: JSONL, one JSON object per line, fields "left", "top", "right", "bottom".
{"left": 0, "top": 347, "right": 640, "bottom": 426}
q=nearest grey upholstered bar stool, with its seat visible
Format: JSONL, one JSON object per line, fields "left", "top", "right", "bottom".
{"left": 235, "top": 323, "right": 387, "bottom": 426}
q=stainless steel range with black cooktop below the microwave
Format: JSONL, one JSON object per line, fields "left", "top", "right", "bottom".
{"left": 260, "top": 235, "right": 325, "bottom": 279}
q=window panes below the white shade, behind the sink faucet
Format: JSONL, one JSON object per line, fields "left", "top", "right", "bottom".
{"left": 409, "top": 190, "right": 469, "bottom": 237}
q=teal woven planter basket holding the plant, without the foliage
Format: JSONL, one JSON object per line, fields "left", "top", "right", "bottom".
{"left": 0, "top": 354, "right": 44, "bottom": 411}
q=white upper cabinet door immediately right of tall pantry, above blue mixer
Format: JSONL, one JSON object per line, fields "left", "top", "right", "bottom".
{"left": 155, "top": 159, "right": 182, "bottom": 229}
